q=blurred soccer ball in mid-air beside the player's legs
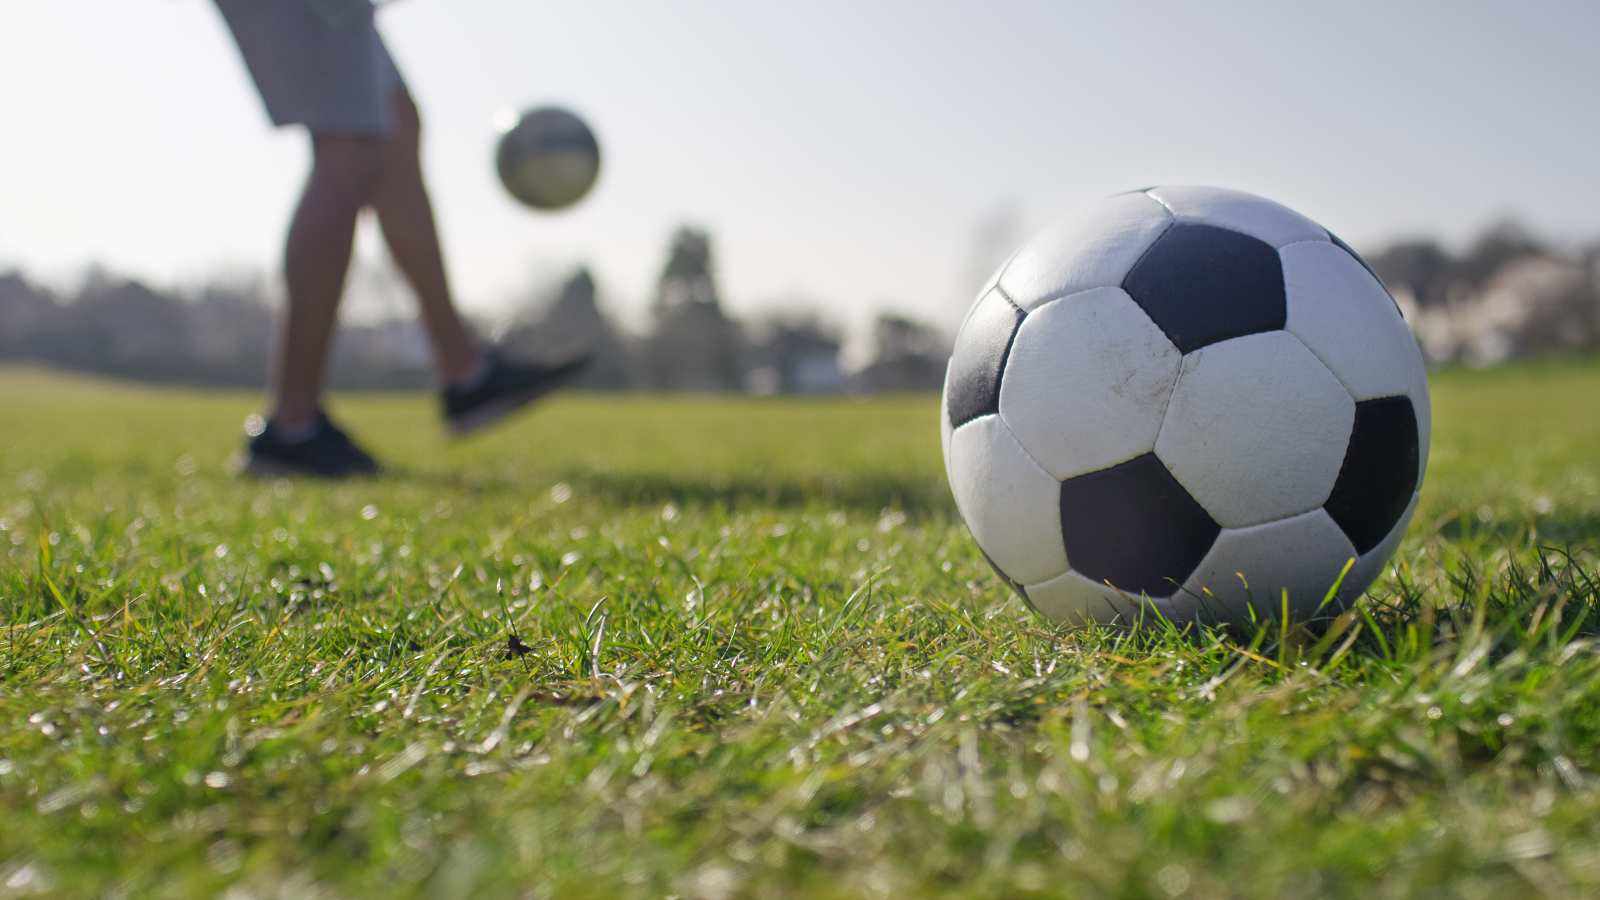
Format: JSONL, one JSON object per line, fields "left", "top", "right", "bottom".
{"left": 494, "top": 106, "right": 600, "bottom": 210}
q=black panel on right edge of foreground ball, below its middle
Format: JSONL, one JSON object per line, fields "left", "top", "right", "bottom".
{"left": 1322, "top": 397, "right": 1421, "bottom": 552}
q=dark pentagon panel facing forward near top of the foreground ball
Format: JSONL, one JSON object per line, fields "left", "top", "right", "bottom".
{"left": 1122, "top": 224, "right": 1288, "bottom": 352}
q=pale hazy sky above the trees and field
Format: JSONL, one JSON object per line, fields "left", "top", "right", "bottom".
{"left": 0, "top": 0, "right": 1600, "bottom": 351}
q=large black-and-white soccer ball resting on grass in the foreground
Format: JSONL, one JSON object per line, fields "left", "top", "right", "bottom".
{"left": 941, "top": 187, "right": 1429, "bottom": 623}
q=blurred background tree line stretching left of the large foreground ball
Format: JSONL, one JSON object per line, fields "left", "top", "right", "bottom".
{"left": 0, "top": 227, "right": 949, "bottom": 394}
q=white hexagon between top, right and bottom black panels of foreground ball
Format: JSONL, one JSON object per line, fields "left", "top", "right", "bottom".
{"left": 1155, "top": 331, "right": 1355, "bottom": 528}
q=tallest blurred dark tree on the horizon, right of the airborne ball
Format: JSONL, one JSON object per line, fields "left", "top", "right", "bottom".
{"left": 643, "top": 226, "right": 744, "bottom": 392}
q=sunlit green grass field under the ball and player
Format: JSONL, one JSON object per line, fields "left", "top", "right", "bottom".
{"left": 0, "top": 364, "right": 1600, "bottom": 900}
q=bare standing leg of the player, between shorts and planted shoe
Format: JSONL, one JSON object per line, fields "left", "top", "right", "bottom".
{"left": 272, "top": 135, "right": 386, "bottom": 431}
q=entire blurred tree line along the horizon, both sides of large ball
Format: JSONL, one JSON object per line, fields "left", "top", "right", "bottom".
{"left": 0, "top": 224, "right": 1600, "bottom": 394}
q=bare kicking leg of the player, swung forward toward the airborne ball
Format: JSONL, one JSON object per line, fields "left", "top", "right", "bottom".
{"left": 371, "top": 90, "right": 482, "bottom": 384}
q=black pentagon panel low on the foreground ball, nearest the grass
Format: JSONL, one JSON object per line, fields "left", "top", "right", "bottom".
{"left": 1061, "top": 453, "right": 1222, "bottom": 597}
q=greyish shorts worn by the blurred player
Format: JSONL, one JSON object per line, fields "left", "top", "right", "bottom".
{"left": 216, "top": 0, "right": 405, "bottom": 135}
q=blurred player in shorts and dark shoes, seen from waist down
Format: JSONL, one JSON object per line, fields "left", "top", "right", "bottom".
{"left": 216, "top": 0, "right": 589, "bottom": 477}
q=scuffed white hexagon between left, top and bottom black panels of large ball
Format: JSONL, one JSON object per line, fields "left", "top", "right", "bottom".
{"left": 1000, "top": 288, "right": 1182, "bottom": 479}
